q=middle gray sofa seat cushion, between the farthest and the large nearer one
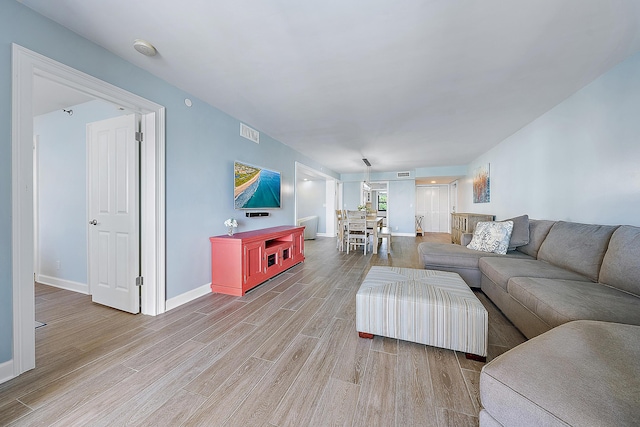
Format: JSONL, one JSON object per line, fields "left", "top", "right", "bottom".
{"left": 478, "top": 257, "right": 589, "bottom": 292}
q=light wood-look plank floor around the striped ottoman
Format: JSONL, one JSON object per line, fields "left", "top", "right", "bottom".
{"left": 0, "top": 234, "right": 525, "bottom": 426}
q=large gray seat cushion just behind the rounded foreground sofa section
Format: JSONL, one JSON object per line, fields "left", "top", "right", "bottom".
{"left": 507, "top": 277, "right": 640, "bottom": 328}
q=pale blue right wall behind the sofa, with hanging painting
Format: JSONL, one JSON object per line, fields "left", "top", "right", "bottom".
{"left": 458, "top": 53, "right": 640, "bottom": 226}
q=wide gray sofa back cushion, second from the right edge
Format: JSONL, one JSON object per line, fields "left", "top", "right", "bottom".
{"left": 538, "top": 221, "right": 618, "bottom": 282}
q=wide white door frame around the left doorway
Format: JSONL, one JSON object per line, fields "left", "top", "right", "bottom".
{"left": 11, "top": 44, "right": 166, "bottom": 376}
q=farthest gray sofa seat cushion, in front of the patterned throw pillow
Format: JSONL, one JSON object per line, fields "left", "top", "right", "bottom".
{"left": 418, "top": 242, "right": 531, "bottom": 268}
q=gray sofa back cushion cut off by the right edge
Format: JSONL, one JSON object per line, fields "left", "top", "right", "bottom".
{"left": 599, "top": 225, "right": 640, "bottom": 296}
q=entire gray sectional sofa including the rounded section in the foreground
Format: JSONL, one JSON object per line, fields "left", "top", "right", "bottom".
{"left": 418, "top": 216, "right": 640, "bottom": 426}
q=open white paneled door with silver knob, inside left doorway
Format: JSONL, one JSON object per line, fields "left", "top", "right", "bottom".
{"left": 87, "top": 114, "right": 140, "bottom": 313}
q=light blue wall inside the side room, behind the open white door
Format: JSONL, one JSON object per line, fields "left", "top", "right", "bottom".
{"left": 33, "top": 101, "right": 123, "bottom": 285}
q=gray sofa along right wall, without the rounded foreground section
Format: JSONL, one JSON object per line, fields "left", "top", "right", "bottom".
{"left": 418, "top": 217, "right": 640, "bottom": 338}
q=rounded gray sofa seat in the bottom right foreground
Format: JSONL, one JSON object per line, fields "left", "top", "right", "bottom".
{"left": 480, "top": 320, "right": 640, "bottom": 426}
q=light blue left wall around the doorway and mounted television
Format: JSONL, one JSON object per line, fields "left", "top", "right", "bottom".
{"left": 0, "top": 1, "right": 338, "bottom": 363}
